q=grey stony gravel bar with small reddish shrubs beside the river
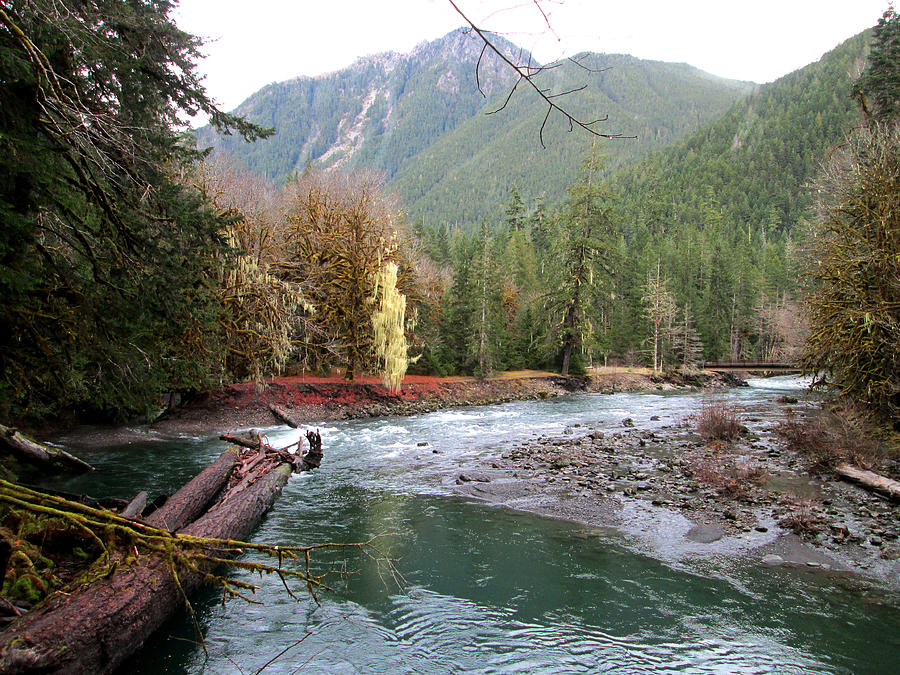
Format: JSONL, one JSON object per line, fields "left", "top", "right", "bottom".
{"left": 452, "top": 406, "right": 900, "bottom": 591}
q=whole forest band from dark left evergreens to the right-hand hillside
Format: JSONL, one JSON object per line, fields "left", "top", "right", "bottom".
{"left": 0, "top": 3, "right": 895, "bottom": 434}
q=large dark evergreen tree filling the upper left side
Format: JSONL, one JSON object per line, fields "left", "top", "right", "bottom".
{"left": 0, "top": 0, "right": 261, "bottom": 416}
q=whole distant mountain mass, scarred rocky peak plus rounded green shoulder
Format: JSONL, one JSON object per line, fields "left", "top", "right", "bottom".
{"left": 198, "top": 29, "right": 753, "bottom": 223}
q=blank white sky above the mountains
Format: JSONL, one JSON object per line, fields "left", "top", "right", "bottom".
{"left": 174, "top": 0, "right": 889, "bottom": 110}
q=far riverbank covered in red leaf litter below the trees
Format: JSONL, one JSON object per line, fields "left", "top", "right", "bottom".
{"left": 52, "top": 367, "right": 741, "bottom": 448}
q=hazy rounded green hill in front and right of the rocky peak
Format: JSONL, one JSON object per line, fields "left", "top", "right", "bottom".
{"left": 391, "top": 54, "right": 752, "bottom": 223}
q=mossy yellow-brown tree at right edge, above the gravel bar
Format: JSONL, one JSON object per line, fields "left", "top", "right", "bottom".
{"left": 804, "top": 122, "right": 900, "bottom": 420}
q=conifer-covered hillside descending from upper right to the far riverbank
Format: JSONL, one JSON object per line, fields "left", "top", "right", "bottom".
{"left": 419, "top": 34, "right": 867, "bottom": 371}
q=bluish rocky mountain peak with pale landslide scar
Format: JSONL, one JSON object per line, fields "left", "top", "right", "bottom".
{"left": 198, "top": 29, "right": 528, "bottom": 182}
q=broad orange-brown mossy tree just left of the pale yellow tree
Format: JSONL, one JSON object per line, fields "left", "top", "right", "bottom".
{"left": 281, "top": 173, "right": 408, "bottom": 380}
